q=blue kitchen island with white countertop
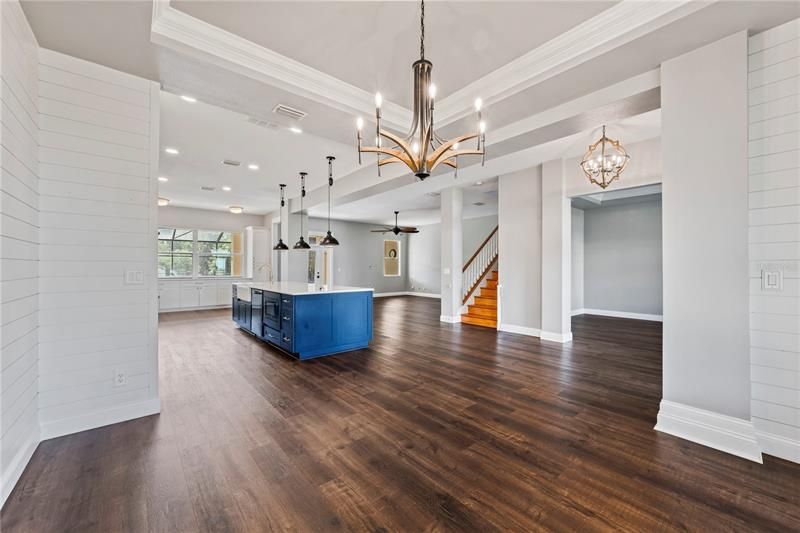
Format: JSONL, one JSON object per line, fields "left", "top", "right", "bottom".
{"left": 232, "top": 281, "right": 372, "bottom": 360}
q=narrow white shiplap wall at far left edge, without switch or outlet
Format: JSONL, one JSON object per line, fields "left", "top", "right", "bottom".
{"left": 0, "top": 2, "right": 39, "bottom": 504}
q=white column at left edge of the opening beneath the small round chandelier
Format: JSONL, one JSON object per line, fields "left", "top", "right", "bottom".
{"left": 541, "top": 159, "right": 572, "bottom": 342}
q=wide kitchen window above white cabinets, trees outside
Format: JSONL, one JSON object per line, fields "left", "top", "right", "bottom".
{"left": 158, "top": 228, "right": 244, "bottom": 278}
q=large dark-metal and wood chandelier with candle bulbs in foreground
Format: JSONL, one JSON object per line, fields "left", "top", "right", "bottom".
{"left": 357, "top": 0, "right": 486, "bottom": 180}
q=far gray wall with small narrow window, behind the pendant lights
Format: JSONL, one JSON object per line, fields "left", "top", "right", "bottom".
{"left": 306, "top": 218, "right": 406, "bottom": 293}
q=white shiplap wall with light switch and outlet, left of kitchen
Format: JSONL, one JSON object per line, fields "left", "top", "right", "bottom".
{"left": 39, "top": 49, "right": 159, "bottom": 439}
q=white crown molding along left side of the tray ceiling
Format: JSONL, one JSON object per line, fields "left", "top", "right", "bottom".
{"left": 150, "top": 0, "right": 411, "bottom": 131}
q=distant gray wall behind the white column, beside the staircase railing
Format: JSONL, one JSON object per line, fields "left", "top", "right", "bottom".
{"left": 408, "top": 215, "right": 497, "bottom": 294}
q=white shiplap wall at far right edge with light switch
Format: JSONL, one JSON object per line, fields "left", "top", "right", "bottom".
{"left": 748, "top": 19, "right": 800, "bottom": 462}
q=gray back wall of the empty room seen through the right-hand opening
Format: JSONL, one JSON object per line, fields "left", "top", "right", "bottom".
{"left": 582, "top": 200, "right": 663, "bottom": 315}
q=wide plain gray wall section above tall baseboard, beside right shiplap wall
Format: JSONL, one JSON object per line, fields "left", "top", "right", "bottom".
{"left": 661, "top": 31, "right": 750, "bottom": 421}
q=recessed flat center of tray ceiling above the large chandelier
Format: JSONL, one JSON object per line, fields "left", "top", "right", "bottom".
{"left": 171, "top": 0, "right": 616, "bottom": 108}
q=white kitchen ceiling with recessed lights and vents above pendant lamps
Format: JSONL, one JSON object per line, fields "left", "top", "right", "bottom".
{"left": 159, "top": 92, "right": 358, "bottom": 214}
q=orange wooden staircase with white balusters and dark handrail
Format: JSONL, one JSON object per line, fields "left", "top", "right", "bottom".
{"left": 461, "top": 227, "right": 498, "bottom": 328}
